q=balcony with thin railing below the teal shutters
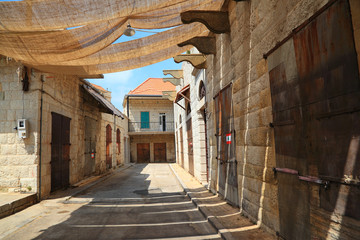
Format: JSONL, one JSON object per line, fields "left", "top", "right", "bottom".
{"left": 129, "top": 122, "right": 174, "bottom": 134}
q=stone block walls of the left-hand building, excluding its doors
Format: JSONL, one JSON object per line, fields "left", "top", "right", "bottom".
{"left": 0, "top": 57, "right": 128, "bottom": 198}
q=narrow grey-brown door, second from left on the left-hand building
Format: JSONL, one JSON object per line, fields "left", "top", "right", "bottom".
{"left": 84, "top": 117, "right": 96, "bottom": 176}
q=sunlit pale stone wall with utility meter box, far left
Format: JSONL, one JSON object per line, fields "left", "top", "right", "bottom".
{"left": 0, "top": 56, "right": 40, "bottom": 191}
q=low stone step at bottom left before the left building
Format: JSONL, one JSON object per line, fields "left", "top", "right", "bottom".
{"left": 0, "top": 193, "right": 37, "bottom": 219}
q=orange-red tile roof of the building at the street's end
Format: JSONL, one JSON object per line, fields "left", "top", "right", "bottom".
{"left": 128, "top": 78, "right": 176, "bottom": 95}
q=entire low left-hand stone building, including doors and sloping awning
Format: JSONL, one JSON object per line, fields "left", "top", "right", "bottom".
{"left": 0, "top": 56, "right": 128, "bottom": 198}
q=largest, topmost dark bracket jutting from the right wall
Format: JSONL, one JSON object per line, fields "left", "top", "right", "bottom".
{"left": 180, "top": 10, "right": 230, "bottom": 34}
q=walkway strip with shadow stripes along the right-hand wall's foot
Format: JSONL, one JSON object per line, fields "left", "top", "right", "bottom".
{"left": 169, "top": 164, "right": 276, "bottom": 240}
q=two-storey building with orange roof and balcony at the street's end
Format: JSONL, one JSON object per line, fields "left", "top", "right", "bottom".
{"left": 123, "top": 78, "right": 175, "bottom": 163}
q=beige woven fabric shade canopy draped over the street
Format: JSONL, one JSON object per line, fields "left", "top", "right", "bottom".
{"left": 0, "top": 0, "right": 223, "bottom": 75}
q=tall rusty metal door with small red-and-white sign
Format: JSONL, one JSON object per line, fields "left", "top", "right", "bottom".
{"left": 215, "top": 84, "right": 239, "bottom": 206}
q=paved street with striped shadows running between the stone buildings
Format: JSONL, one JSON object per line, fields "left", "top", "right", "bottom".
{"left": 0, "top": 164, "right": 220, "bottom": 239}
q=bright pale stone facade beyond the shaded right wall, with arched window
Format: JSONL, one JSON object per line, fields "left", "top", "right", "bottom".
{"left": 174, "top": 49, "right": 210, "bottom": 185}
